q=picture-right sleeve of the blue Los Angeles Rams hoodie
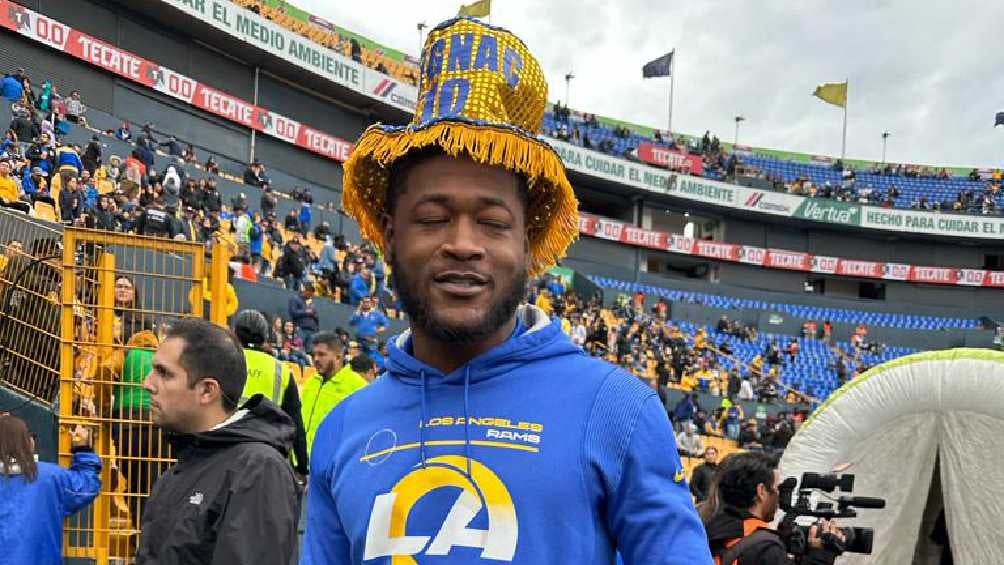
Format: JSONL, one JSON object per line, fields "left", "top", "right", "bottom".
{"left": 585, "top": 370, "right": 712, "bottom": 565}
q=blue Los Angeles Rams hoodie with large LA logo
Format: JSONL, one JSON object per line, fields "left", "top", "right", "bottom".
{"left": 301, "top": 306, "right": 712, "bottom": 565}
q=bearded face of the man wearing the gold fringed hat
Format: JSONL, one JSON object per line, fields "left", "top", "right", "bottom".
{"left": 385, "top": 157, "right": 528, "bottom": 343}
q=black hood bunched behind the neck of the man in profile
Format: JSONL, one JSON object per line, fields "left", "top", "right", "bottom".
{"left": 168, "top": 394, "right": 296, "bottom": 459}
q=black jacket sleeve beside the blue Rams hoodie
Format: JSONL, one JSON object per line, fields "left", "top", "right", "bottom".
{"left": 211, "top": 457, "right": 299, "bottom": 565}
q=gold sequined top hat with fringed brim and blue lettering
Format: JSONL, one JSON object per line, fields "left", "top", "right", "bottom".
{"left": 341, "top": 18, "right": 578, "bottom": 275}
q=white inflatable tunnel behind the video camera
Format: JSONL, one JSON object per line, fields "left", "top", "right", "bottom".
{"left": 780, "top": 349, "right": 1004, "bottom": 565}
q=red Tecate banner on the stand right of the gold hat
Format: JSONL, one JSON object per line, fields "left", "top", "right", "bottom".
{"left": 578, "top": 214, "right": 1004, "bottom": 288}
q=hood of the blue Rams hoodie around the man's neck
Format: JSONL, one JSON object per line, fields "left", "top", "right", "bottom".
{"left": 387, "top": 305, "right": 582, "bottom": 386}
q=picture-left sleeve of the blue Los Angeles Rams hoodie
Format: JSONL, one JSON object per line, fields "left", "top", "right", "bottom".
{"left": 300, "top": 401, "right": 352, "bottom": 565}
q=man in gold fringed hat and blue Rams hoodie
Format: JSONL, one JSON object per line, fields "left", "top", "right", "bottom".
{"left": 301, "top": 18, "right": 712, "bottom": 565}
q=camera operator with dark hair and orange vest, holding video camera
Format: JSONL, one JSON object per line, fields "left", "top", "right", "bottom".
{"left": 702, "top": 453, "right": 843, "bottom": 565}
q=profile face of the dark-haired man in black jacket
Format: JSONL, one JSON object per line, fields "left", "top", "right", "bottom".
{"left": 143, "top": 337, "right": 208, "bottom": 433}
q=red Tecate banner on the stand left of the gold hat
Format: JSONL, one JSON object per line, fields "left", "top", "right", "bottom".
{"left": 0, "top": 0, "right": 352, "bottom": 161}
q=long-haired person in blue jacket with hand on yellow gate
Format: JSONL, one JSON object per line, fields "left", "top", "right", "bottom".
{"left": 0, "top": 414, "right": 101, "bottom": 565}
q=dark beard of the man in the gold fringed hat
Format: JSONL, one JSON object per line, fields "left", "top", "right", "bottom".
{"left": 391, "top": 254, "right": 528, "bottom": 345}
